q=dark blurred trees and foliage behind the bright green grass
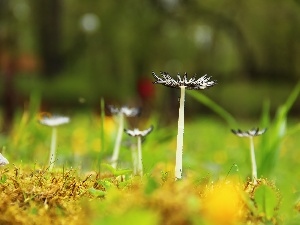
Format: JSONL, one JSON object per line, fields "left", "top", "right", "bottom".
{"left": 0, "top": 0, "right": 300, "bottom": 128}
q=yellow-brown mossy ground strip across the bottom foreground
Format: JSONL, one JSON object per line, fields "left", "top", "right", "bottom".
{"left": 0, "top": 166, "right": 278, "bottom": 225}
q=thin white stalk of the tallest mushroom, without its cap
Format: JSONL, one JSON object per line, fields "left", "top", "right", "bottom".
{"left": 175, "top": 86, "right": 185, "bottom": 180}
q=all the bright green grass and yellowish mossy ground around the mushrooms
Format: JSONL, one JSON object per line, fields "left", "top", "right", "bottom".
{"left": 0, "top": 85, "right": 300, "bottom": 225}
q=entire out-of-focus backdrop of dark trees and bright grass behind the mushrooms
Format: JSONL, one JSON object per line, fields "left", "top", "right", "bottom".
{"left": 0, "top": 0, "right": 300, "bottom": 223}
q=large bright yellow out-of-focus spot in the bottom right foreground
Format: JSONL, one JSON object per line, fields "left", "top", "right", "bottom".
{"left": 203, "top": 181, "right": 243, "bottom": 225}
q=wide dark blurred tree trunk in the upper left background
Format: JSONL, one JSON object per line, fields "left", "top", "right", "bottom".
{"left": 33, "top": 0, "right": 64, "bottom": 78}
